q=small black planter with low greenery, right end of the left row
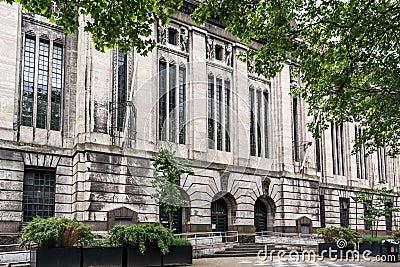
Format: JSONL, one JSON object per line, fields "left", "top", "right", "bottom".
{"left": 162, "top": 237, "right": 193, "bottom": 266}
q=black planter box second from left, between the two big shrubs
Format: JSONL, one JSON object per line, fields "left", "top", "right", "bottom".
{"left": 82, "top": 247, "right": 124, "bottom": 267}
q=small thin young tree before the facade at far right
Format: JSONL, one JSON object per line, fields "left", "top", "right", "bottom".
{"left": 353, "top": 180, "right": 400, "bottom": 236}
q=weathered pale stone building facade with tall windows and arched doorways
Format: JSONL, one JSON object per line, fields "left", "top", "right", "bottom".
{"left": 0, "top": 3, "right": 399, "bottom": 241}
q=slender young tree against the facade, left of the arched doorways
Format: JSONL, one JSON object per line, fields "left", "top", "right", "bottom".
{"left": 151, "top": 148, "right": 194, "bottom": 230}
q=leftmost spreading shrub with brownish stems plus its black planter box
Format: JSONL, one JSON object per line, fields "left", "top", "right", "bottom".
{"left": 21, "top": 217, "right": 93, "bottom": 267}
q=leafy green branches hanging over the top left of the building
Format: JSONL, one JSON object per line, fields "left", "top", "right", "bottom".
{"left": 0, "top": 0, "right": 183, "bottom": 55}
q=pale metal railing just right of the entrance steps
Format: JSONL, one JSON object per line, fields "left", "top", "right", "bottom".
{"left": 256, "top": 231, "right": 323, "bottom": 246}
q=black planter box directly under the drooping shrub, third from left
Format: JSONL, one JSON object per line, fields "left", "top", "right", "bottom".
{"left": 125, "top": 245, "right": 162, "bottom": 267}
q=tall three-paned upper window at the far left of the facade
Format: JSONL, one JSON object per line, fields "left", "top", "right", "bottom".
{"left": 21, "top": 35, "right": 63, "bottom": 131}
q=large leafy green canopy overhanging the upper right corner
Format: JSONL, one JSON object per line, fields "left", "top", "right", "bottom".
{"left": 192, "top": 0, "right": 400, "bottom": 157}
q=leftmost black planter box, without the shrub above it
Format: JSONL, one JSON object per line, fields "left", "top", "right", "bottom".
{"left": 31, "top": 248, "right": 81, "bottom": 267}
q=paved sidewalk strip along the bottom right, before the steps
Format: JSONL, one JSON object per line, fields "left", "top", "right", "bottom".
{"left": 192, "top": 257, "right": 400, "bottom": 267}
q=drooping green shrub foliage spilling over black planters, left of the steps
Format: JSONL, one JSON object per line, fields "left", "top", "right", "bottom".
{"left": 108, "top": 223, "right": 173, "bottom": 254}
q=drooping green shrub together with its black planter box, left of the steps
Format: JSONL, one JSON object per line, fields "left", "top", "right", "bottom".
{"left": 109, "top": 223, "right": 173, "bottom": 267}
